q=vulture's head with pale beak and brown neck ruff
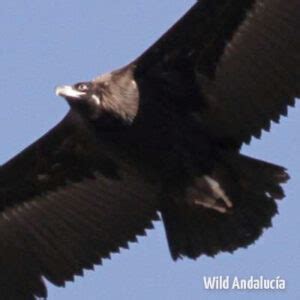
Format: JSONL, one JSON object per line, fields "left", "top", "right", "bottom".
{"left": 56, "top": 69, "right": 139, "bottom": 123}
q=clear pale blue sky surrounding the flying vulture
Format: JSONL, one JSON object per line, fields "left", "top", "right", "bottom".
{"left": 0, "top": 0, "right": 300, "bottom": 300}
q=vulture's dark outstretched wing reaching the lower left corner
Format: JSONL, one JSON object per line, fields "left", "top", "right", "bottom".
{"left": 0, "top": 113, "right": 157, "bottom": 300}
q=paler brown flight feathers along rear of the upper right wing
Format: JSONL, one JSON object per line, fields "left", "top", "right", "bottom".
{"left": 200, "top": 0, "right": 300, "bottom": 143}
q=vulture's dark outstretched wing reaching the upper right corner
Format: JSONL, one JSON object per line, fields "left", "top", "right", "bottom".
{"left": 135, "top": 0, "right": 300, "bottom": 146}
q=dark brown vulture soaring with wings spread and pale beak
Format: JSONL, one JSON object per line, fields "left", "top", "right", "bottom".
{"left": 0, "top": 0, "right": 300, "bottom": 300}
